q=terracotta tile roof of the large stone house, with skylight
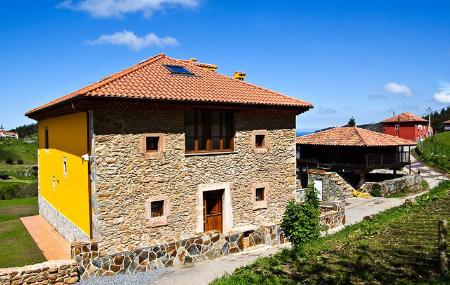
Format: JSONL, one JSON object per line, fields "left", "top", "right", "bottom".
{"left": 27, "top": 54, "right": 312, "bottom": 115}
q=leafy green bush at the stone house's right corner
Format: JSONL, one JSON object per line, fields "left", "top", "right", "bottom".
{"left": 281, "top": 185, "right": 320, "bottom": 248}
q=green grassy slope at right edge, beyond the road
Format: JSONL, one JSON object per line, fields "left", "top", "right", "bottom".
{"left": 415, "top": 132, "right": 450, "bottom": 173}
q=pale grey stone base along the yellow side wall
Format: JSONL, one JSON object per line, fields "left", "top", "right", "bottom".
{"left": 38, "top": 195, "right": 89, "bottom": 242}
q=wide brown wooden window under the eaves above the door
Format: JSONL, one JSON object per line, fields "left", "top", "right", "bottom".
{"left": 184, "top": 110, "right": 234, "bottom": 152}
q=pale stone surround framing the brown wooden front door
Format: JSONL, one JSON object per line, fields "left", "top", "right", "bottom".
{"left": 196, "top": 182, "right": 233, "bottom": 234}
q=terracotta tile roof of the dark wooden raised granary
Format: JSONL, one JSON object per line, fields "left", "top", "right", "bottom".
{"left": 297, "top": 127, "right": 416, "bottom": 146}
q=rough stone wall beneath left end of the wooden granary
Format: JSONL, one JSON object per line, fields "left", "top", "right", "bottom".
{"left": 308, "top": 169, "right": 355, "bottom": 201}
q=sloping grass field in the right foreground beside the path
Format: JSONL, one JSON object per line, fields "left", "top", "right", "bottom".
{"left": 213, "top": 182, "right": 450, "bottom": 285}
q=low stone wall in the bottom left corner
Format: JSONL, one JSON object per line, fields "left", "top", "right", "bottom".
{"left": 0, "top": 259, "right": 79, "bottom": 285}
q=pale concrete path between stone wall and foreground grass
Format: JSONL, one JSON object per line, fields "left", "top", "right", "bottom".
{"left": 151, "top": 244, "right": 290, "bottom": 285}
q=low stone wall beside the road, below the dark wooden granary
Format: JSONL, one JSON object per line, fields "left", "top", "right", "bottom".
{"left": 359, "top": 174, "right": 422, "bottom": 196}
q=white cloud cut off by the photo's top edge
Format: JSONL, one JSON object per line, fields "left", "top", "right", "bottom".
{"left": 58, "top": 0, "right": 199, "bottom": 18}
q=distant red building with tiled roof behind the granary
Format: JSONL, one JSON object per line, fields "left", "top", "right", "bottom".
{"left": 381, "top": 112, "right": 431, "bottom": 141}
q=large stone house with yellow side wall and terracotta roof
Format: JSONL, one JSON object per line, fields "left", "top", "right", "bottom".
{"left": 26, "top": 54, "right": 312, "bottom": 251}
